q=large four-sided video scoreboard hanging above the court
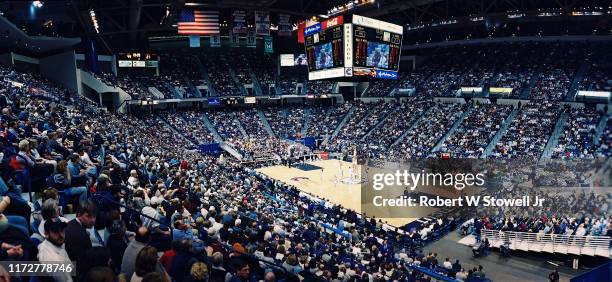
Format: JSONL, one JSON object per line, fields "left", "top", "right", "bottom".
{"left": 304, "top": 15, "right": 403, "bottom": 80}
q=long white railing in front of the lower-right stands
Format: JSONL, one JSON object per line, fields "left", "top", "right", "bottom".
{"left": 480, "top": 229, "right": 612, "bottom": 257}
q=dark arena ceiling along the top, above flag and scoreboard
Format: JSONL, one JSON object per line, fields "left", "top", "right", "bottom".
{"left": 0, "top": 0, "right": 610, "bottom": 52}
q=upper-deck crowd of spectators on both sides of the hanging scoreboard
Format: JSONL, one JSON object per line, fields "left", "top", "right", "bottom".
{"left": 77, "top": 42, "right": 612, "bottom": 101}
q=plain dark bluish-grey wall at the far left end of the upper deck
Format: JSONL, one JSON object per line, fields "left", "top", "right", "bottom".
{"left": 40, "top": 51, "right": 79, "bottom": 92}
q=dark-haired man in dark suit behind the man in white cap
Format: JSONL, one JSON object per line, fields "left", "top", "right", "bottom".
{"left": 65, "top": 200, "right": 98, "bottom": 273}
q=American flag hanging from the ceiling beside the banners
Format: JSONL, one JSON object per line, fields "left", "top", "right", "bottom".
{"left": 178, "top": 10, "right": 219, "bottom": 35}
